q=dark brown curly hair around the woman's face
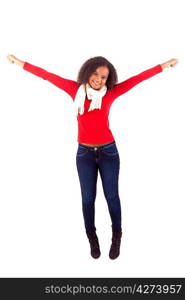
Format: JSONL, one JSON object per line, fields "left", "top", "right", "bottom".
{"left": 77, "top": 56, "right": 118, "bottom": 89}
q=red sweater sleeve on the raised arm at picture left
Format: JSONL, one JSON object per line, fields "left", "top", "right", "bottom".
{"left": 23, "top": 62, "right": 79, "bottom": 100}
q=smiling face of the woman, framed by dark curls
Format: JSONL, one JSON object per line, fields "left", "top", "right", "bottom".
{"left": 88, "top": 66, "right": 109, "bottom": 90}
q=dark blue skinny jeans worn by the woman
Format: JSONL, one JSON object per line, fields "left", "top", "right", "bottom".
{"left": 76, "top": 141, "right": 121, "bottom": 232}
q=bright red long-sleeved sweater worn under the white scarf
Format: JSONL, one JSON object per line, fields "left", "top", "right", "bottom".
{"left": 23, "top": 62, "right": 162, "bottom": 144}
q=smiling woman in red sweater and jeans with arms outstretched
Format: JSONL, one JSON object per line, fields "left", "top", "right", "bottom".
{"left": 8, "top": 55, "right": 178, "bottom": 259}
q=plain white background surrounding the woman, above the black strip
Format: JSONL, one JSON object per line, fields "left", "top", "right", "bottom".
{"left": 0, "top": 0, "right": 185, "bottom": 277}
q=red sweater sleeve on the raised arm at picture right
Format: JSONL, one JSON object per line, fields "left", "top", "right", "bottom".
{"left": 112, "top": 65, "right": 162, "bottom": 99}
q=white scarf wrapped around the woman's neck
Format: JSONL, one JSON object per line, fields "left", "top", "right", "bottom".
{"left": 74, "top": 83, "right": 107, "bottom": 115}
